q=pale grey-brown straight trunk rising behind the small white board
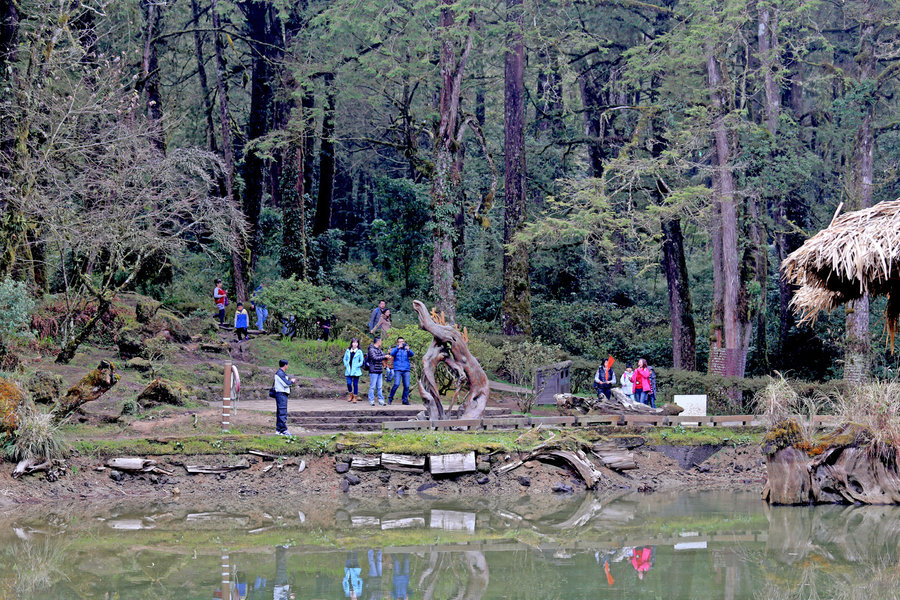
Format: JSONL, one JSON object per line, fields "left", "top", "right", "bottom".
{"left": 706, "top": 53, "right": 749, "bottom": 377}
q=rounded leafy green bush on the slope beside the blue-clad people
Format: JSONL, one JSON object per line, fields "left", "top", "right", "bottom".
{"left": 261, "top": 277, "right": 337, "bottom": 338}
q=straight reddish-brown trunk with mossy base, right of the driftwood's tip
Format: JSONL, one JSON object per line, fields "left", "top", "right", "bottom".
{"left": 500, "top": 0, "right": 531, "bottom": 335}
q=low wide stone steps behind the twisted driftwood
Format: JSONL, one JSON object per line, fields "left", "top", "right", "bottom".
{"left": 287, "top": 403, "right": 510, "bottom": 431}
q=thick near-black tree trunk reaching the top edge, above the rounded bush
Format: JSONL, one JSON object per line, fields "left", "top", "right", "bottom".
{"left": 243, "top": 0, "right": 281, "bottom": 276}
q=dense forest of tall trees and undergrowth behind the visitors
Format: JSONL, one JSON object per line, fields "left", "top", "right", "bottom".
{"left": 0, "top": 0, "right": 900, "bottom": 390}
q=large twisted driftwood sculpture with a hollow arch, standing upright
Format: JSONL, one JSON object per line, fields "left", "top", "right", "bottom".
{"left": 413, "top": 300, "right": 489, "bottom": 419}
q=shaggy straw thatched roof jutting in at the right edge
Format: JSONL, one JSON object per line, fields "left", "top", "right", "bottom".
{"left": 781, "top": 200, "right": 900, "bottom": 349}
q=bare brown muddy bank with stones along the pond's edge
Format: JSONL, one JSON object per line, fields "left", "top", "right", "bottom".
{"left": 0, "top": 444, "right": 766, "bottom": 511}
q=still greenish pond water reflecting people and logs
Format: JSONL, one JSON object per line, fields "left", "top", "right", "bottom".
{"left": 0, "top": 492, "right": 900, "bottom": 600}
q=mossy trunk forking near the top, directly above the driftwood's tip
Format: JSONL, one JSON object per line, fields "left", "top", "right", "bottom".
{"left": 431, "top": 0, "right": 474, "bottom": 323}
